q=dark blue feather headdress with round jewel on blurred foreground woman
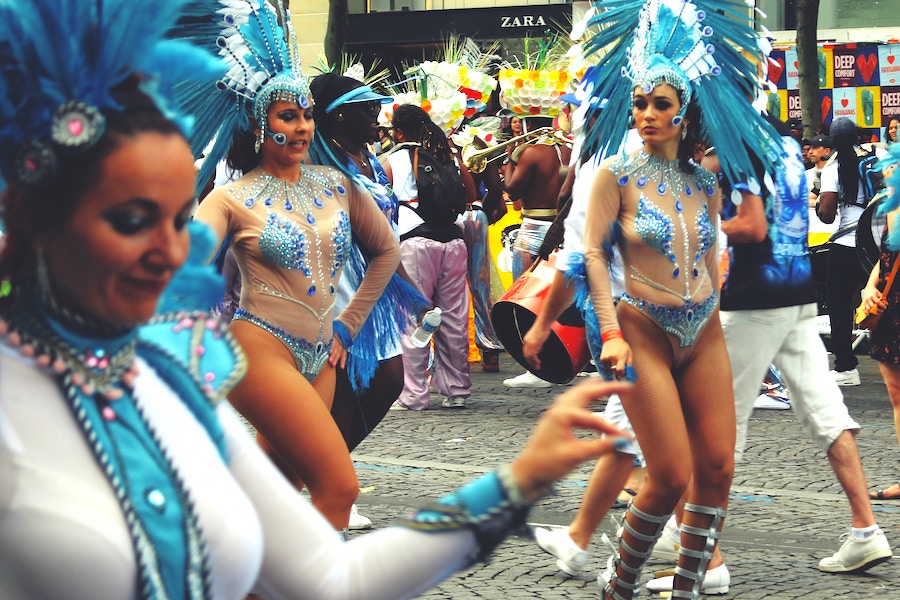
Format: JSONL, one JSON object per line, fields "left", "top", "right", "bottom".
{"left": 0, "top": 0, "right": 222, "bottom": 190}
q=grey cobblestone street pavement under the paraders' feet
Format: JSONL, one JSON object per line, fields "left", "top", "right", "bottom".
{"left": 353, "top": 355, "right": 900, "bottom": 600}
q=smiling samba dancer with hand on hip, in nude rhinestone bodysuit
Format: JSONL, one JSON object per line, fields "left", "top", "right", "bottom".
{"left": 174, "top": 0, "right": 399, "bottom": 529}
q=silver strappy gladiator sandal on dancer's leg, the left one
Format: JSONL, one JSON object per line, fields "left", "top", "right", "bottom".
{"left": 600, "top": 503, "right": 671, "bottom": 600}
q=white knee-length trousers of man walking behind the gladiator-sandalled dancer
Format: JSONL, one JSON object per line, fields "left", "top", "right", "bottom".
{"left": 721, "top": 304, "right": 859, "bottom": 460}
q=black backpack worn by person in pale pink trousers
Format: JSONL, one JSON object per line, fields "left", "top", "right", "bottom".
{"left": 408, "top": 145, "right": 466, "bottom": 225}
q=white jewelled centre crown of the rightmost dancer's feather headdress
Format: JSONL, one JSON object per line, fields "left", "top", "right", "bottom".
{"left": 622, "top": 0, "right": 722, "bottom": 126}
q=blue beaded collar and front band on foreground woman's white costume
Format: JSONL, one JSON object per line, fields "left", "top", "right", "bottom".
{"left": 0, "top": 289, "right": 211, "bottom": 600}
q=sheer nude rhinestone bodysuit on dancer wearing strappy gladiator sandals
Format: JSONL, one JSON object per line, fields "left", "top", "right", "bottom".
{"left": 585, "top": 150, "right": 720, "bottom": 347}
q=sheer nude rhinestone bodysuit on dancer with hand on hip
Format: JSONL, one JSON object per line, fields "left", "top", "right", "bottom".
{"left": 197, "top": 165, "right": 399, "bottom": 380}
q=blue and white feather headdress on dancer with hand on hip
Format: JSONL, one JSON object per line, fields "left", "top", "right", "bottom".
{"left": 173, "top": 0, "right": 310, "bottom": 186}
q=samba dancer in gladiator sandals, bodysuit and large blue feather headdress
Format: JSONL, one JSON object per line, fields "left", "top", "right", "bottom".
{"left": 583, "top": 0, "right": 780, "bottom": 600}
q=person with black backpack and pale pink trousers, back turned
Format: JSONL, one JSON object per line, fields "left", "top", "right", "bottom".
{"left": 379, "top": 104, "right": 475, "bottom": 410}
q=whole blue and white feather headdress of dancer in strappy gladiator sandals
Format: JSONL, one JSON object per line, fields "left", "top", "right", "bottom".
{"left": 584, "top": 0, "right": 781, "bottom": 181}
